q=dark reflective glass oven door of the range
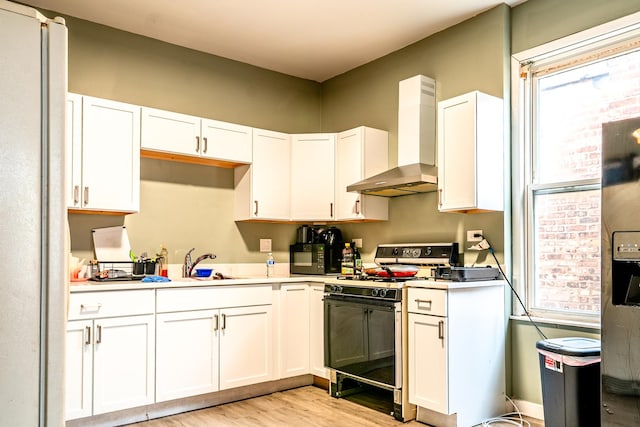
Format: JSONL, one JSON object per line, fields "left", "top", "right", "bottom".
{"left": 324, "top": 294, "right": 402, "bottom": 387}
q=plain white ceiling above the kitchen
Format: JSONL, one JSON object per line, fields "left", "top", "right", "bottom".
{"left": 23, "top": 0, "right": 525, "bottom": 82}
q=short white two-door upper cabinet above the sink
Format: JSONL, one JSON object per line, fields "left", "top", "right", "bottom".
{"left": 141, "top": 107, "right": 252, "bottom": 166}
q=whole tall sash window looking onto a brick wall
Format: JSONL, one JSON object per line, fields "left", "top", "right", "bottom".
{"left": 513, "top": 16, "right": 640, "bottom": 322}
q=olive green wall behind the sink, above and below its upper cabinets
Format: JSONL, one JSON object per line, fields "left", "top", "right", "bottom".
{"left": 60, "top": 13, "right": 322, "bottom": 263}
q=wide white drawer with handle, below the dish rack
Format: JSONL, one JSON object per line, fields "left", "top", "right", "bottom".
{"left": 69, "top": 289, "right": 155, "bottom": 320}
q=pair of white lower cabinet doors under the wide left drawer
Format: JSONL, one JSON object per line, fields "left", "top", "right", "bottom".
{"left": 66, "top": 315, "right": 155, "bottom": 419}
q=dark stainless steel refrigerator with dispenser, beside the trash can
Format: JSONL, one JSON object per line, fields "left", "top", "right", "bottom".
{"left": 601, "top": 117, "right": 640, "bottom": 426}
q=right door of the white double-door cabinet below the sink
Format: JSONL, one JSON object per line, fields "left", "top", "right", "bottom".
{"left": 220, "top": 305, "right": 274, "bottom": 390}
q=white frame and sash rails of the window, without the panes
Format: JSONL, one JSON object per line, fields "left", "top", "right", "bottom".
{"left": 511, "top": 12, "right": 640, "bottom": 327}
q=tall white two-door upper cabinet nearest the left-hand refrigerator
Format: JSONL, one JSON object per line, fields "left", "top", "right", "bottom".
{"left": 67, "top": 95, "right": 140, "bottom": 212}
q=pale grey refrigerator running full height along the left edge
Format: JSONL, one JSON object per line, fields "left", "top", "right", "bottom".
{"left": 0, "top": 0, "right": 68, "bottom": 426}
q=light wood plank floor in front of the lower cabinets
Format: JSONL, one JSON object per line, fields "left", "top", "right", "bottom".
{"left": 125, "top": 386, "right": 542, "bottom": 427}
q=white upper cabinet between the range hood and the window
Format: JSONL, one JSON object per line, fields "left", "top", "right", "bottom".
{"left": 438, "top": 91, "right": 504, "bottom": 212}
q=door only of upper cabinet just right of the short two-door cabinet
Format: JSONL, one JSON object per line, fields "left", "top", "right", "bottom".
{"left": 249, "top": 129, "right": 291, "bottom": 220}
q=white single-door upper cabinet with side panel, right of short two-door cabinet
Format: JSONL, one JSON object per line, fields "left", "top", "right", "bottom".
{"left": 234, "top": 129, "right": 291, "bottom": 221}
